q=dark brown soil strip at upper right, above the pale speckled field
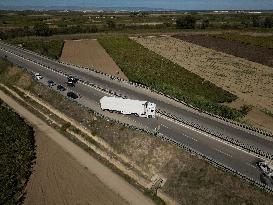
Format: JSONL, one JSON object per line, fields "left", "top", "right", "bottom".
{"left": 174, "top": 34, "right": 273, "bottom": 67}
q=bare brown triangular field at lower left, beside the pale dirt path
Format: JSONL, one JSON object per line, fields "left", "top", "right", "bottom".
{"left": 24, "top": 130, "right": 127, "bottom": 205}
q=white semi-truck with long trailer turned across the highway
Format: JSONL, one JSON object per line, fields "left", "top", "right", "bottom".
{"left": 100, "top": 96, "right": 156, "bottom": 118}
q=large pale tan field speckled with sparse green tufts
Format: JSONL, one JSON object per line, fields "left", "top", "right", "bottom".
{"left": 133, "top": 36, "right": 273, "bottom": 129}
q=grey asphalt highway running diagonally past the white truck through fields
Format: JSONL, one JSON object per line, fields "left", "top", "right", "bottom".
{"left": 0, "top": 41, "right": 273, "bottom": 191}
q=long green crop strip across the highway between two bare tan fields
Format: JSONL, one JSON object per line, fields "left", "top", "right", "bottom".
{"left": 98, "top": 37, "right": 242, "bottom": 119}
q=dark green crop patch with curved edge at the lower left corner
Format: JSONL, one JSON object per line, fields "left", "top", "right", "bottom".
{"left": 0, "top": 100, "right": 35, "bottom": 204}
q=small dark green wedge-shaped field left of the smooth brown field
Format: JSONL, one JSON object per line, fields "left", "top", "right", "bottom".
{"left": 9, "top": 39, "right": 64, "bottom": 59}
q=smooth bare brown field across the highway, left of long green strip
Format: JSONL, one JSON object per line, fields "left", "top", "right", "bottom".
{"left": 60, "top": 39, "right": 128, "bottom": 80}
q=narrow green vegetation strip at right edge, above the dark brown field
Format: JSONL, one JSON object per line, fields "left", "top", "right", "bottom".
{"left": 215, "top": 33, "right": 273, "bottom": 49}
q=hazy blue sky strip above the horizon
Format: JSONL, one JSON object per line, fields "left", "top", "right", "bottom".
{"left": 0, "top": 0, "right": 273, "bottom": 10}
